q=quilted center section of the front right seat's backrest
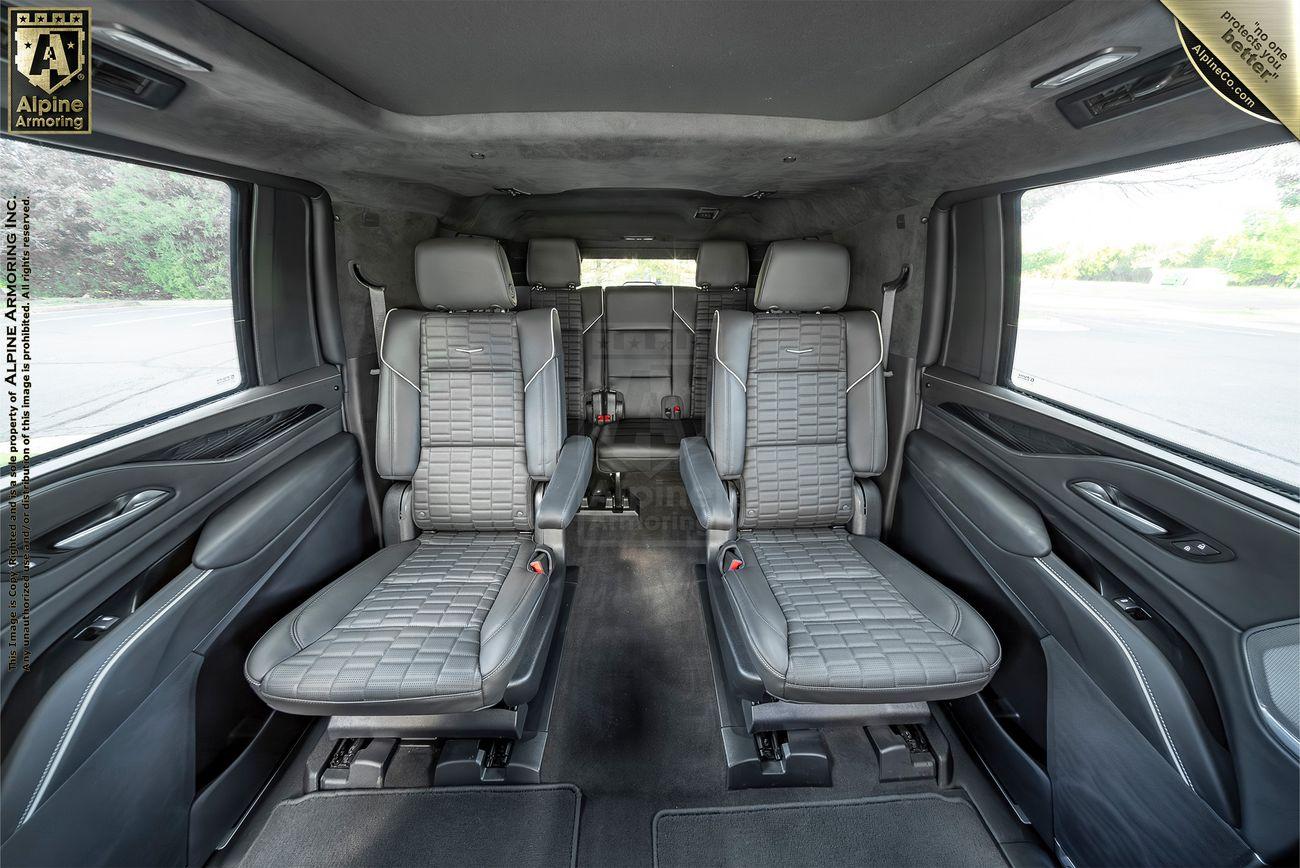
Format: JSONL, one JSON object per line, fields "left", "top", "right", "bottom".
{"left": 740, "top": 313, "right": 853, "bottom": 528}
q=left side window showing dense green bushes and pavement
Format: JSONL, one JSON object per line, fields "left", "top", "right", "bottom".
{"left": 0, "top": 139, "right": 244, "bottom": 461}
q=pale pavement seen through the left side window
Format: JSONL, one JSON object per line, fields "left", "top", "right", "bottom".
{"left": 31, "top": 301, "right": 239, "bottom": 451}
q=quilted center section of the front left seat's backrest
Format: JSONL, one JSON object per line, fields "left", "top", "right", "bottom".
{"left": 411, "top": 312, "right": 532, "bottom": 530}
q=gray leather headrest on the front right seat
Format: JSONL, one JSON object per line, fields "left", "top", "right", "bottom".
{"left": 754, "top": 240, "right": 849, "bottom": 311}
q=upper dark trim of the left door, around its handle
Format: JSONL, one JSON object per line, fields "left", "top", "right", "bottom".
{"left": 0, "top": 365, "right": 342, "bottom": 706}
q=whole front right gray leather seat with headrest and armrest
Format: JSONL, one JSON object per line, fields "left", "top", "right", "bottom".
{"left": 681, "top": 242, "right": 1001, "bottom": 704}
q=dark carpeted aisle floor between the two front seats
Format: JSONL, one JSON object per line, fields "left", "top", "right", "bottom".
{"left": 542, "top": 468, "right": 982, "bottom": 865}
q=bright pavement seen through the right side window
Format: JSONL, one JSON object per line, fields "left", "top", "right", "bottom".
{"left": 1014, "top": 282, "right": 1300, "bottom": 485}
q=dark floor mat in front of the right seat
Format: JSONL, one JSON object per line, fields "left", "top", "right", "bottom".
{"left": 654, "top": 795, "right": 1006, "bottom": 868}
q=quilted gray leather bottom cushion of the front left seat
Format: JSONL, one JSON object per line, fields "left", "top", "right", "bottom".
{"left": 247, "top": 533, "right": 546, "bottom": 715}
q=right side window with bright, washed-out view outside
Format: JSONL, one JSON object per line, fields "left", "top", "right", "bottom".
{"left": 1009, "top": 144, "right": 1300, "bottom": 491}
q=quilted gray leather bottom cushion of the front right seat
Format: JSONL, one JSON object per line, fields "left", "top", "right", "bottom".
{"left": 724, "top": 529, "right": 1000, "bottom": 703}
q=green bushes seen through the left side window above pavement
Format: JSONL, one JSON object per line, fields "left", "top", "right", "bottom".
{"left": 0, "top": 139, "right": 230, "bottom": 299}
